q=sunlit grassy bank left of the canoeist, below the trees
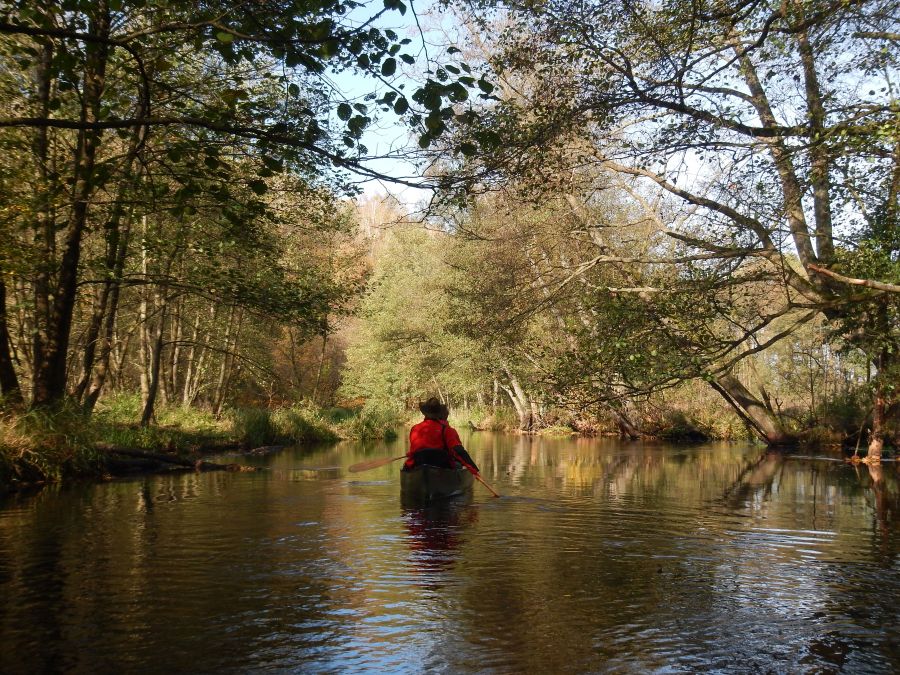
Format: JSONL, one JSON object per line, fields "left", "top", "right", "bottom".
{"left": 0, "top": 395, "right": 402, "bottom": 491}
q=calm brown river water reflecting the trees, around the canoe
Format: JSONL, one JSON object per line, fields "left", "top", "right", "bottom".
{"left": 0, "top": 433, "right": 900, "bottom": 673}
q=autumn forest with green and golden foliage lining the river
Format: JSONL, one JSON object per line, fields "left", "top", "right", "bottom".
{"left": 0, "top": 0, "right": 900, "bottom": 483}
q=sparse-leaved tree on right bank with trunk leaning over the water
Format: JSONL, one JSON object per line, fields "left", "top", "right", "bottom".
{"left": 446, "top": 0, "right": 900, "bottom": 460}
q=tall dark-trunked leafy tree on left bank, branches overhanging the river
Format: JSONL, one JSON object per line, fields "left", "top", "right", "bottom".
{"left": 0, "top": 0, "right": 474, "bottom": 405}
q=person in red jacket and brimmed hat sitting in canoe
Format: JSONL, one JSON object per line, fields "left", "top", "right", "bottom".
{"left": 403, "top": 396, "right": 479, "bottom": 473}
